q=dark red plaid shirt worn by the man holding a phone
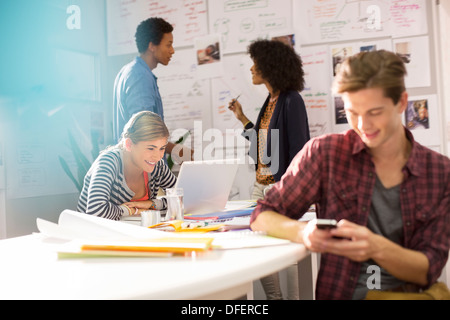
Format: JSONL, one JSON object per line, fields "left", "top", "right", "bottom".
{"left": 251, "top": 128, "right": 450, "bottom": 299}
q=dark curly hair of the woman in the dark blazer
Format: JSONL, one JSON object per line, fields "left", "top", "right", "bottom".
{"left": 248, "top": 40, "right": 305, "bottom": 92}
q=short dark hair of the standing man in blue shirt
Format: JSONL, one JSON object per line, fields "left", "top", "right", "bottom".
{"left": 135, "top": 18, "right": 173, "bottom": 53}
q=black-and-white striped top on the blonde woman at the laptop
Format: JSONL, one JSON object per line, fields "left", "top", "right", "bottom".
{"left": 77, "top": 148, "right": 176, "bottom": 220}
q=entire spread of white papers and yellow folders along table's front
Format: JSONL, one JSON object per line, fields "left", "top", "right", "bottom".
{"left": 37, "top": 210, "right": 289, "bottom": 258}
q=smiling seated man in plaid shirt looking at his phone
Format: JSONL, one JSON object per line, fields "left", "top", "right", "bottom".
{"left": 251, "top": 50, "right": 450, "bottom": 299}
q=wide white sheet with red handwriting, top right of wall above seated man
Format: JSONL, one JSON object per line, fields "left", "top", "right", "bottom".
{"left": 293, "top": 0, "right": 428, "bottom": 45}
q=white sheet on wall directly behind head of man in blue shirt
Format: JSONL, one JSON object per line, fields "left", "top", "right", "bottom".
{"left": 106, "top": 0, "right": 208, "bottom": 55}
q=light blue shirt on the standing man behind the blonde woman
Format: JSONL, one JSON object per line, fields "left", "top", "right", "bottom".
{"left": 113, "top": 57, "right": 164, "bottom": 142}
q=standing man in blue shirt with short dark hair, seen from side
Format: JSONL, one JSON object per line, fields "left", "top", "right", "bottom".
{"left": 113, "top": 18, "right": 175, "bottom": 153}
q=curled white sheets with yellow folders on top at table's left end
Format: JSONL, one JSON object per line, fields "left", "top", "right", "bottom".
{"left": 37, "top": 210, "right": 213, "bottom": 257}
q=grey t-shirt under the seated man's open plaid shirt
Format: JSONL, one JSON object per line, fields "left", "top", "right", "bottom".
{"left": 353, "top": 177, "right": 405, "bottom": 300}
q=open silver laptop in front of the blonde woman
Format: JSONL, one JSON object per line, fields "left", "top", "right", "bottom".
{"left": 175, "top": 159, "right": 239, "bottom": 214}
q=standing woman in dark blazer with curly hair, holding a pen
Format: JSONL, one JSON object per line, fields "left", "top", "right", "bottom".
{"left": 229, "top": 40, "right": 310, "bottom": 299}
